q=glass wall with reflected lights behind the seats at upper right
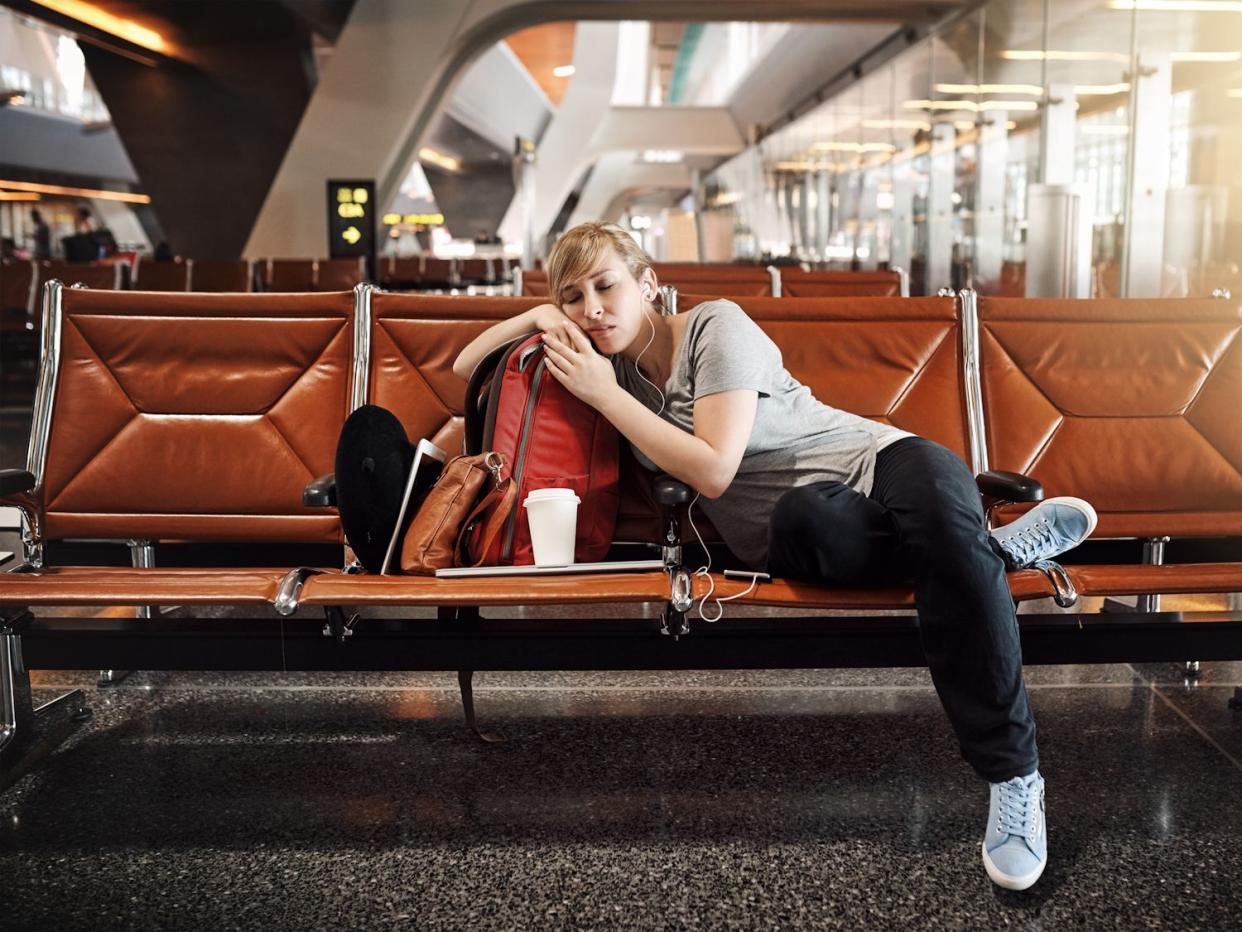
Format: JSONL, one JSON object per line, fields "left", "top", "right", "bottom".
{"left": 704, "top": 0, "right": 1242, "bottom": 297}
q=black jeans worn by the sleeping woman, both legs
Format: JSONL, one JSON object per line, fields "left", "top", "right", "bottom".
{"left": 768, "top": 437, "right": 1040, "bottom": 782}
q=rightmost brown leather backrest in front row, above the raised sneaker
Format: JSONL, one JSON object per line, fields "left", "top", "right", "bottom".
{"left": 979, "top": 297, "right": 1242, "bottom": 537}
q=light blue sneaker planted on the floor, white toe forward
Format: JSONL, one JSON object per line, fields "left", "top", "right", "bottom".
{"left": 984, "top": 770, "right": 1048, "bottom": 890}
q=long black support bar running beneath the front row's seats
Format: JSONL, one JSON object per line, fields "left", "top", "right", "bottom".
{"left": 14, "top": 609, "right": 1242, "bottom": 671}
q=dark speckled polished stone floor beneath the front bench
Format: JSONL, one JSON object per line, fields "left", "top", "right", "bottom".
{"left": 0, "top": 664, "right": 1242, "bottom": 930}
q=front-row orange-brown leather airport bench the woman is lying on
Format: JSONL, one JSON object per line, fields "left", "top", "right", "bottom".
{"left": 0, "top": 283, "right": 1242, "bottom": 775}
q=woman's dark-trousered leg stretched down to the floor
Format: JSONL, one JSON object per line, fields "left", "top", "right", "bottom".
{"left": 871, "top": 437, "right": 1040, "bottom": 783}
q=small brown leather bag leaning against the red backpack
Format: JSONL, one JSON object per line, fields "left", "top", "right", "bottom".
{"left": 401, "top": 452, "right": 518, "bottom": 575}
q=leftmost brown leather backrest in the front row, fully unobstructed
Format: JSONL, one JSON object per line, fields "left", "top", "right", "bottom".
{"left": 42, "top": 288, "right": 353, "bottom": 542}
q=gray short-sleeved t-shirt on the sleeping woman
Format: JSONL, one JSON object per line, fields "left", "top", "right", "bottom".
{"left": 612, "top": 301, "right": 914, "bottom": 569}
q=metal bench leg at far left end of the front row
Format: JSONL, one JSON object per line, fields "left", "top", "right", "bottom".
{"left": 0, "top": 629, "right": 91, "bottom": 789}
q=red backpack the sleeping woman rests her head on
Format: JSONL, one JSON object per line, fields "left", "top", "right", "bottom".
{"left": 465, "top": 333, "right": 620, "bottom": 565}
